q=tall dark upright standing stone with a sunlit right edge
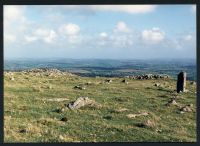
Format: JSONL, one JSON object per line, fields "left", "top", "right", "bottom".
{"left": 176, "top": 72, "right": 186, "bottom": 93}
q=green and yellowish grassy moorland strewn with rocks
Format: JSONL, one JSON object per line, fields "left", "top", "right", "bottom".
{"left": 4, "top": 72, "right": 197, "bottom": 142}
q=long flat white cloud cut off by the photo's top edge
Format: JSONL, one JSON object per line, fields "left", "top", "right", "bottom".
{"left": 88, "top": 5, "right": 157, "bottom": 14}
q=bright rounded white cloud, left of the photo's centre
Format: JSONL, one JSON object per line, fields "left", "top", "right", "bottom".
{"left": 59, "top": 23, "right": 80, "bottom": 35}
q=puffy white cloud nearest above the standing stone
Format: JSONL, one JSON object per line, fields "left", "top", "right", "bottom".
{"left": 142, "top": 27, "right": 165, "bottom": 43}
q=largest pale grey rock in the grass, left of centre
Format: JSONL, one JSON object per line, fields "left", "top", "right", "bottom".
{"left": 67, "top": 97, "right": 100, "bottom": 109}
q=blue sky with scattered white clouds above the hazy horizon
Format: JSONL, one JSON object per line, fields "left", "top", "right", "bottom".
{"left": 4, "top": 5, "right": 196, "bottom": 59}
